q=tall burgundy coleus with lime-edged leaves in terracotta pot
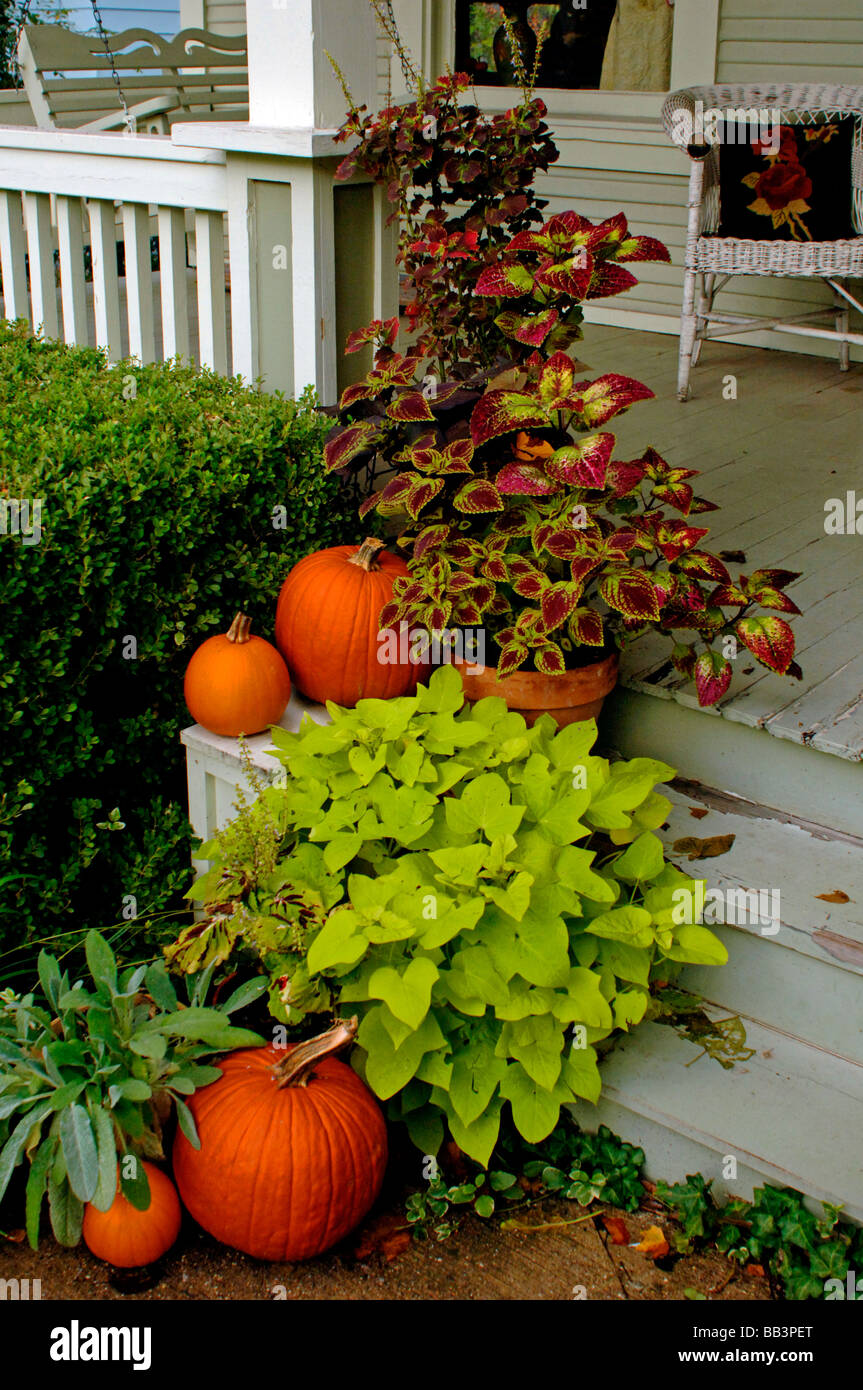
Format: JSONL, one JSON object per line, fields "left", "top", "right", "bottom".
{"left": 325, "top": 78, "right": 800, "bottom": 705}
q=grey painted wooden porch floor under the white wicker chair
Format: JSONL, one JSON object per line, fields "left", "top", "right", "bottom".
{"left": 586, "top": 324, "right": 863, "bottom": 762}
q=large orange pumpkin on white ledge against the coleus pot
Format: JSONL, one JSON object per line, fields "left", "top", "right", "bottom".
{"left": 275, "top": 539, "right": 420, "bottom": 709}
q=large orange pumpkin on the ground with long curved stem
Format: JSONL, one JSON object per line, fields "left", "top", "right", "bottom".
{"left": 174, "top": 1019, "right": 386, "bottom": 1259}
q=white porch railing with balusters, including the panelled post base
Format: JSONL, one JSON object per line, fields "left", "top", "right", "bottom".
{"left": 0, "top": 122, "right": 397, "bottom": 403}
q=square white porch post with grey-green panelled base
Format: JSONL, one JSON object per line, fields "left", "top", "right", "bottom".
{"left": 171, "top": 0, "right": 397, "bottom": 404}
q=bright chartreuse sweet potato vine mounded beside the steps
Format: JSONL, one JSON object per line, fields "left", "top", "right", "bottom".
{"left": 170, "top": 667, "right": 725, "bottom": 1163}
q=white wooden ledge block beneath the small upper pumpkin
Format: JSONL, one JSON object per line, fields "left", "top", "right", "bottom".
{"left": 179, "top": 692, "right": 329, "bottom": 873}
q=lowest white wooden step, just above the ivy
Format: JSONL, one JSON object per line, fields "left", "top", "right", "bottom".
{"left": 575, "top": 1013, "right": 863, "bottom": 1222}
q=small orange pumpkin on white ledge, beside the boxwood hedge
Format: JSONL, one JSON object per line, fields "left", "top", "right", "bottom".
{"left": 183, "top": 613, "right": 290, "bottom": 738}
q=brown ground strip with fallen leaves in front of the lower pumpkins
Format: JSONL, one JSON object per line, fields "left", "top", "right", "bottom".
{"left": 0, "top": 1198, "right": 770, "bottom": 1301}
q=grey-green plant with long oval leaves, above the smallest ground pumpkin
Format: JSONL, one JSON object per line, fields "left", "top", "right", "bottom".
{"left": 0, "top": 931, "right": 264, "bottom": 1248}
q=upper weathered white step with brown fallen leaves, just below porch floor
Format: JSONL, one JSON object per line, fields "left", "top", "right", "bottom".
{"left": 661, "top": 788, "right": 863, "bottom": 1063}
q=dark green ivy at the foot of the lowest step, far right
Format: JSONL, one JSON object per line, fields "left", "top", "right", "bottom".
{"left": 656, "top": 1173, "right": 863, "bottom": 1301}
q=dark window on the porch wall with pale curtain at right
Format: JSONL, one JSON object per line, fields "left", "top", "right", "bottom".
{"left": 456, "top": 0, "right": 674, "bottom": 92}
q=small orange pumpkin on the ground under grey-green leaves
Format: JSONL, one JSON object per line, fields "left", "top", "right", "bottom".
{"left": 83, "top": 1159, "right": 182, "bottom": 1269}
